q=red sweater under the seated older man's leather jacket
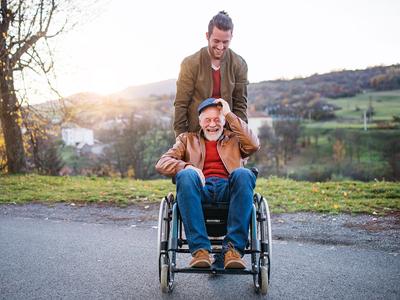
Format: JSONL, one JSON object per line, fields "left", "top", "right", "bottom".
{"left": 203, "top": 141, "right": 229, "bottom": 178}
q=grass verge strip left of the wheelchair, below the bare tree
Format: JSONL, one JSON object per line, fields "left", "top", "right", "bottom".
{"left": 0, "top": 175, "right": 173, "bottom": 205}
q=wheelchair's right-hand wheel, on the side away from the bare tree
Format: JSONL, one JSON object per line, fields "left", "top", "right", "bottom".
{"left": 254, "top": 194, "right": 272, "bottom": 295}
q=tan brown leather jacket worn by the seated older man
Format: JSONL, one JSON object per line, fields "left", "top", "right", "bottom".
{"left": 156, "top": 112, "right": 260, "bottom": 176}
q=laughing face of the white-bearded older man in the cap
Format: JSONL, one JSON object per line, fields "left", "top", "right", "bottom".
{"left": 199, "top": 106, "right": 225, "bottom": 141}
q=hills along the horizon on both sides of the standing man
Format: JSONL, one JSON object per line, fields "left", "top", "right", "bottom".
{"left": 38, "top": 64, "right": 400, "bottom": 122}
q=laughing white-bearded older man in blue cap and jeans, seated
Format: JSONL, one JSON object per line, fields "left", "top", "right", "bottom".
{"left": 156, "top": 98, "right": 259, "bottom": 269}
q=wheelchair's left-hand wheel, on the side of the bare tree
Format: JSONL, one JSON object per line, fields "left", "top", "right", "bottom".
{"left": 157, "top": 193, "right": 174, "bottom": 293}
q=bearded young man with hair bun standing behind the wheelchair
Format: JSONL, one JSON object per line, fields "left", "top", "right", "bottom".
{"left": 174, "top": 11, "right": 248, "bottom": 136}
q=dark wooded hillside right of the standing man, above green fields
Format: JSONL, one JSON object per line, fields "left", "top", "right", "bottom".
{"left": 249, "top": 65, "right": 400, "bottom": 121}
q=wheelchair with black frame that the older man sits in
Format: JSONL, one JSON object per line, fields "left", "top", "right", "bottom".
{"left": 157, "top": 168, "right": 272, "bottom": 295}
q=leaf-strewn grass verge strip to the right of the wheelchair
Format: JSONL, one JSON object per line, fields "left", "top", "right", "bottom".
{"left": 256, "top": 178, "right": 400, "bottom": 215}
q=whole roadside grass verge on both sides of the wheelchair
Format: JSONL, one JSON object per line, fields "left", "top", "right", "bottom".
{"left": 0, "top": 175, "right": 400, "bottom": 215}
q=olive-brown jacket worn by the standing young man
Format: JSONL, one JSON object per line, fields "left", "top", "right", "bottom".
{"left": 174, "top": 47, "right": 248, "bottom": 136}
